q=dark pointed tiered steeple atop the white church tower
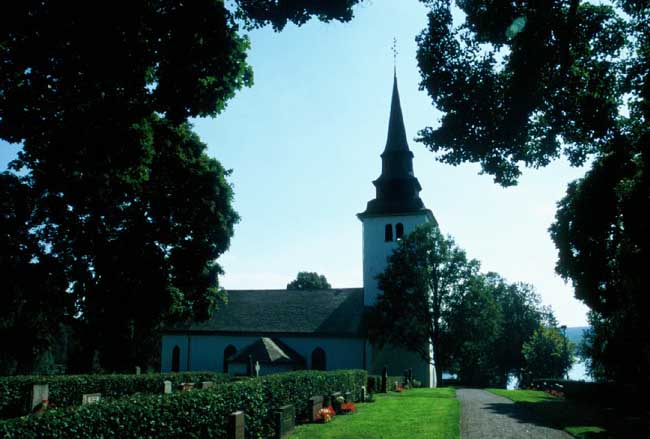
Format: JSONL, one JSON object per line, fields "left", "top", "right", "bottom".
{"left": 358, "top": 74, "right": 425, "bottom": 218}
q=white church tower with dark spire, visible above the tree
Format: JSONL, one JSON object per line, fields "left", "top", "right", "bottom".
{"left": 357, "top": 74, "right": 436, "bottom": 306}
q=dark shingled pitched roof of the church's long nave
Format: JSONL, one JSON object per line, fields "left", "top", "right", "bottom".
{"left": 166, "top": 288, "right": 364, "bottom": 337}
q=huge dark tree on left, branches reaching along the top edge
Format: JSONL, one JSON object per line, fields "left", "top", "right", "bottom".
{"left": 0, "top": 0, "right": 357, "bottom": 370}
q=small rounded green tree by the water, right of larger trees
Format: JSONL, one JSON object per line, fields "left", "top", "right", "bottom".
{"left": 523, "top": 326, "right": 574, "bottom": 383}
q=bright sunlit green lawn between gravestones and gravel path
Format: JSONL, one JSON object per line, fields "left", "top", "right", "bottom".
{"left": 290, "top": 388, "right": 460, "bottom": 439}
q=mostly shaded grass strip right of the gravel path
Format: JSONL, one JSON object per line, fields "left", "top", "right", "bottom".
{"left": 486, "top": 389, "right": 648, "bottom": 439}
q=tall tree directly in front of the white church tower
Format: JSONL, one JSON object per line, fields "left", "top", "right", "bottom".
{"left": 368, "top": 225, "right": 479, "bottom": 379}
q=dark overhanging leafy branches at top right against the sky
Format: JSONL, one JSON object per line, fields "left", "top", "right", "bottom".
{"left": 417, "top": 0, "right": 627, "bottom": 185}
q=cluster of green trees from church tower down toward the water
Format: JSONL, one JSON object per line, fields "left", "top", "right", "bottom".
{"left": 368, "top": 225, "right": 556, "bottom": 386}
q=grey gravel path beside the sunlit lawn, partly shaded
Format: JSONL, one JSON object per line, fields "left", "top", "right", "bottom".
{"left": 456, "top": 389, "right": 571, "bottom": 439}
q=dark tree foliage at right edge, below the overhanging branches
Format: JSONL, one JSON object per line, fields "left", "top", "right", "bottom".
{"left": 550, "top": 150, "right": 650, "bottom": 388}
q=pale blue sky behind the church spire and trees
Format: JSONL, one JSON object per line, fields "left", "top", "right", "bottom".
{"left": 0, "top": 0, "right": 587, "bottom": 326}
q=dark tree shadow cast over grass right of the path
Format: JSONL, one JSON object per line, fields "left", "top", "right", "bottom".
{"left": 478, "top": 399, "right": 650, "bottom": 439}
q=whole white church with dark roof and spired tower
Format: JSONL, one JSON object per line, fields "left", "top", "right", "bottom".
{"left": 161, "top": 76, "right": 436, "bottom": 387}
